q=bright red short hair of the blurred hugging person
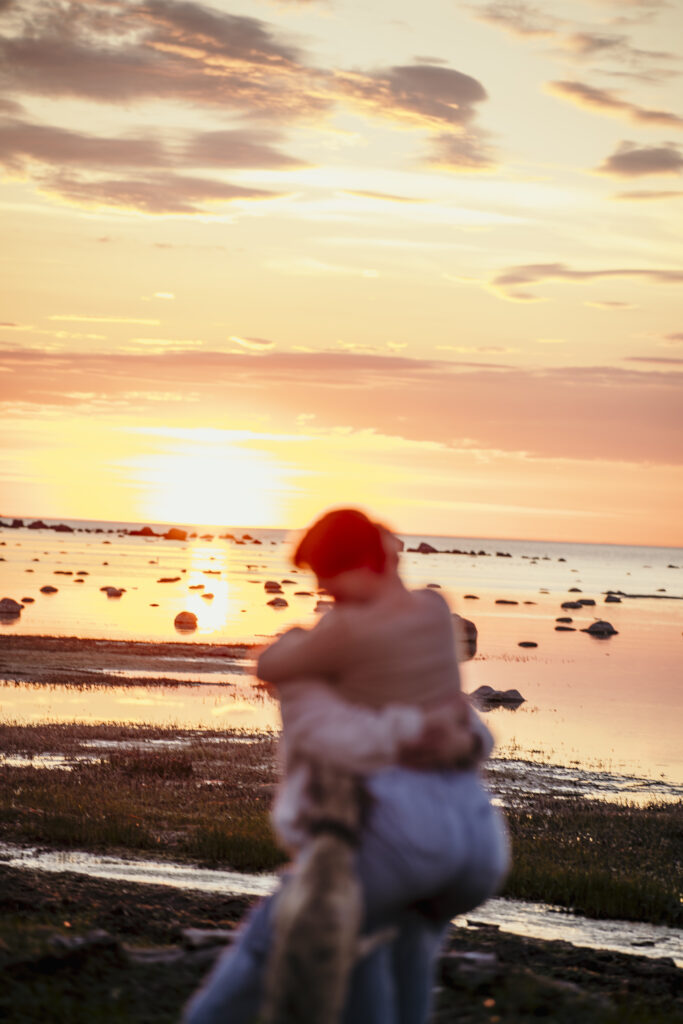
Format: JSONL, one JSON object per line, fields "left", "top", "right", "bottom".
{"left": 294, "top": 509, "right": 386, "bottom": 580}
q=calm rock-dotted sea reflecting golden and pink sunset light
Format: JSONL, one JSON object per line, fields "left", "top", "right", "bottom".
{"left": 0, "top": 520, "right": 683, "bottom": 782}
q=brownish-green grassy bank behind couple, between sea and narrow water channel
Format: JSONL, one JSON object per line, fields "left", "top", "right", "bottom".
{"left": 0, "top": 725, "right": 683, "bottom": 926}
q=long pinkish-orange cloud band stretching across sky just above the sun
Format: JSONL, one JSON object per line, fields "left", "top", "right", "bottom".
{"left": 0, "top": 349, "right": 683, "bottom": 464}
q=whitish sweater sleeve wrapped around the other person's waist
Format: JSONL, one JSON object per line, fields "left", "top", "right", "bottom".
{"left": 280, "top": 680, "right": 423, "bottom": 774}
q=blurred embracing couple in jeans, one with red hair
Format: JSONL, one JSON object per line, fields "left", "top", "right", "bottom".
{"left": 184, "top": 509, "right": 508, "bottom": 1024}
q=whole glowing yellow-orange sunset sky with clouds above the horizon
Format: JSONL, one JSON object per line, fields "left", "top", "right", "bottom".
{"left": 0, "top": 0, "right": 683, "bottom": 545}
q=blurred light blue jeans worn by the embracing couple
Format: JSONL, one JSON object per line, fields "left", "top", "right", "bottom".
{"left": 183, "top": 768, "right": 508, "bottom": 1024}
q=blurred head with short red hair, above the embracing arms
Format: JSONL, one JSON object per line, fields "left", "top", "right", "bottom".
{"left": 294, "top": 509, "right": 400, "bottom": 601}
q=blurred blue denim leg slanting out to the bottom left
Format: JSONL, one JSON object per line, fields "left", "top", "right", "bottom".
{"left": 182, "top": 896, "right": 273, "bottom": 1024}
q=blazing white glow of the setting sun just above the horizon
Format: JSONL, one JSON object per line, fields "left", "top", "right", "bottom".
{"left": 136, "top": 443, "right": 286, "bottom": 526}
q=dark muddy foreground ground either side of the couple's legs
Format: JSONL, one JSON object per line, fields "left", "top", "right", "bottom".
{"left": 0, "top": 865, "right": 683, "bottom": 1024}
